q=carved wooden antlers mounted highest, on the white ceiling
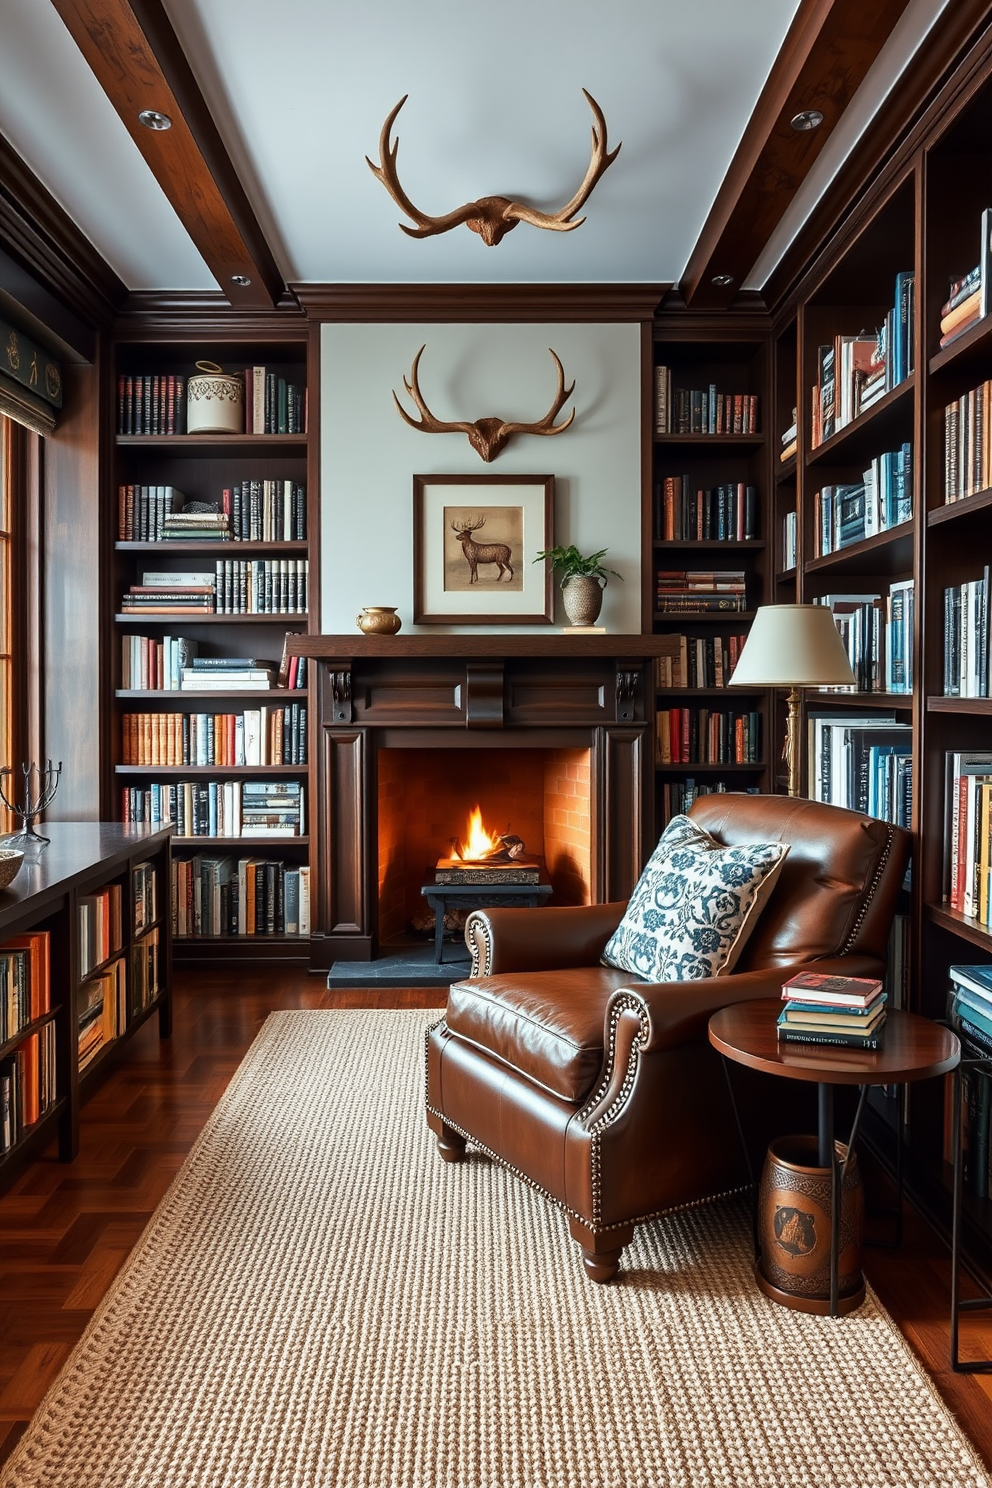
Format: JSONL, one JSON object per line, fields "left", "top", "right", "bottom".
{"left": 366, "top": 88, "right": 620, "bottom": 247}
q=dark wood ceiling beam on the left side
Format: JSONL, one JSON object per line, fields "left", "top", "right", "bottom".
{"left": 52, "top": 0, "right": 284, "bottom": 310}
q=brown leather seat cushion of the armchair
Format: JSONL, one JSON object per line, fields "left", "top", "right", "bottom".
{"left": 445, "top": 966, "right": 637, "bottom": 1104}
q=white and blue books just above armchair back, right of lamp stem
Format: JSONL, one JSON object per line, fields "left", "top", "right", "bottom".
{"left": 809, "top": 710, "right": 913, "bottom": 827}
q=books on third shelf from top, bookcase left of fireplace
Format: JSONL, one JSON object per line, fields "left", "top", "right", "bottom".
{"left": 120, "top": 558, "right": 309, "bottom": 615}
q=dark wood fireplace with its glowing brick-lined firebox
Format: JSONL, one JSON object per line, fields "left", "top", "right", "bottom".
{"left": 292, "top": 634, "right": 672, "bottom": 970}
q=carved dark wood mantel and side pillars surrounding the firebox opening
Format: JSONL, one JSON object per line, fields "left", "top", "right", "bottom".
{"left": 298, "top": 631, "right": 665, "bottom": 969}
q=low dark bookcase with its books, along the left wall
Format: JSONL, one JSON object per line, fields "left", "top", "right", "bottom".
{"left": 0, "top": 821, "right": 173, "bottom": 1189}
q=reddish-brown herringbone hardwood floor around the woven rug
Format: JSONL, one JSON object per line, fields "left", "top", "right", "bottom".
{"left": 0, "top": 970, "right": 992, "bottom": 1467}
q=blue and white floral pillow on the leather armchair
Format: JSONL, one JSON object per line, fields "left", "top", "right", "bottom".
{"left": 602, "top": 815, "right": 788, "bottom": 982}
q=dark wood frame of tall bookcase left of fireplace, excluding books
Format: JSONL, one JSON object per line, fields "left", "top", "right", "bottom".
{"left": 106, "top": 317, "right": 320, "bottom": 964}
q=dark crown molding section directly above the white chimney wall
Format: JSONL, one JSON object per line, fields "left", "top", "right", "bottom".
{"left": 290, "top": 284, "right": 668, "bottom": 323}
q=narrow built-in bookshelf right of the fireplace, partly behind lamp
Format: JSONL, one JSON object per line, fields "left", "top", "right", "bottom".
{"left": 647, "top": 324, "right": 775, "bottom": 830}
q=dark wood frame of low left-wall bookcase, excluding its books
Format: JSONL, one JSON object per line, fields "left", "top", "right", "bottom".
{"left": 0, "top": 821, "right": 173, "bottom": 1189}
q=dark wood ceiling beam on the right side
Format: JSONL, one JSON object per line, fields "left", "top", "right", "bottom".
{"left": 680, "top": 0, "right": 909, "bottom": 308}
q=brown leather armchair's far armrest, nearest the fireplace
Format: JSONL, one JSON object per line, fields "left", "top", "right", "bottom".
{"left": 466, "top": 903, "right": 626, "bottom": 976}
